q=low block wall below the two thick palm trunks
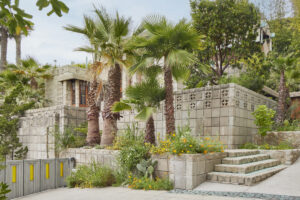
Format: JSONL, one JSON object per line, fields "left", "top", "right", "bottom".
{"left": 59, "top": 148, "right": 119, "bottom": 169}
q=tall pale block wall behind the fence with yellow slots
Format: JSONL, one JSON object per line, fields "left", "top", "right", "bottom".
{"left": 19, "top": 106, "right": 86, "bottom": 159}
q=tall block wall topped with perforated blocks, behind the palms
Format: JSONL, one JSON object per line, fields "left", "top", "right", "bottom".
{"left": 100, "top": 84, "right": 276, "bottom": 148}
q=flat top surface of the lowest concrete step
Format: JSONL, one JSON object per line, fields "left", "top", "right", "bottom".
{"left": 208, "top": 165, "right": 287, "bottom": 178}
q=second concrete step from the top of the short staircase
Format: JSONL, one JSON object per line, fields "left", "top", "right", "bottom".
{"left": 222, "top": 154, "right": 270, "bottom": 165}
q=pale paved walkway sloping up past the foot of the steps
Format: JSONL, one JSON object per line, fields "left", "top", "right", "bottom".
{"left": 195, "top": 159, "right": 300, "bottom": 197}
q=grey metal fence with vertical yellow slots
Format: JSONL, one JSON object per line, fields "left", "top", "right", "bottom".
{"left": 0, "top": 158, "right": 74, "bottom": 199}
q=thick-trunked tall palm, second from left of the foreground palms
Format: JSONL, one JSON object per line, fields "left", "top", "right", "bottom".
{"left": 95, "top": 8, "right": 132, "bottom": 146}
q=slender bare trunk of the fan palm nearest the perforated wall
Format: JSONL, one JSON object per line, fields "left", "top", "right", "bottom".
{"left": 164, "top": 66, "right": 175, "bottom": 134}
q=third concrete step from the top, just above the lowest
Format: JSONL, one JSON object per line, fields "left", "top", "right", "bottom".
{"left": 215, "top": 159, "right": 281, "bottom": 174}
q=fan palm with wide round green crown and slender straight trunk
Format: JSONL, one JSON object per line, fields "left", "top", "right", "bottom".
{"left": 130, "top": 16, "right": 201, "bottom": 134}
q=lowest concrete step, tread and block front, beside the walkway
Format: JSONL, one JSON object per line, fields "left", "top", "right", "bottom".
{"left": 207, "top": 165, "right": 287, "bottom": 186}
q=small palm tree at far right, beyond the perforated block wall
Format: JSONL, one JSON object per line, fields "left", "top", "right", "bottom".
{"left": 271, "top": 55, "right": 298, "bottom": 125}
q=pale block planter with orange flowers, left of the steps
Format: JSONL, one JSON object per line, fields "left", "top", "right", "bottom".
{"left": 152, "top": 153, "right": 226, "bottom": 190}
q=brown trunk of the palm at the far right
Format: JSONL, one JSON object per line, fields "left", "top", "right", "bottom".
{"left": 275, "top": 70, "right": 287, "bottom": 125}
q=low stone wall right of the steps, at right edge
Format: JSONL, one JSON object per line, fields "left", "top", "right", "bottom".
{"left": 259, "top": 149, "right": 300, "bottom": 165}
